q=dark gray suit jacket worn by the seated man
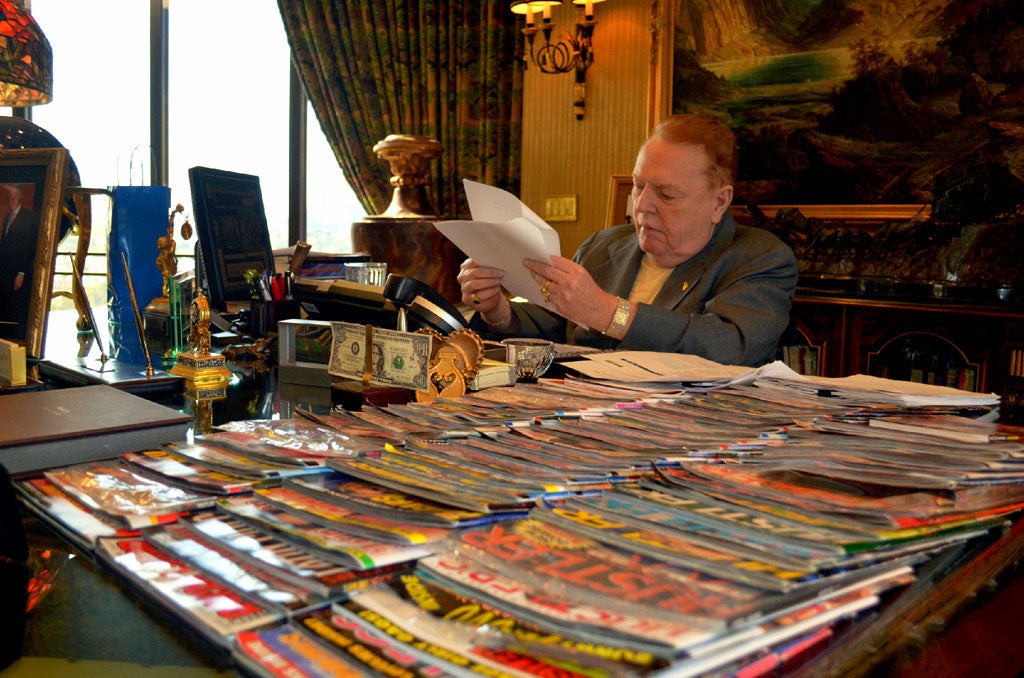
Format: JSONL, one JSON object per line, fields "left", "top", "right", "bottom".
{"left": 474, "top": 213, "right": 799, "bottom": 366}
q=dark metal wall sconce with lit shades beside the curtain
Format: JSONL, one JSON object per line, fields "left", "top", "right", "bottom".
{"left": 512, "top": 0, "right": 604, "bottom": 120}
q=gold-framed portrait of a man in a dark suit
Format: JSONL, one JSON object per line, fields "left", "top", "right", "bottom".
{"left": 0, "top": 149, "right": 69, "bottom": 358}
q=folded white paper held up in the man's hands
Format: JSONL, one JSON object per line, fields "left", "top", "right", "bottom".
{"left": 434, "top": 179, "right": 561, "bottom": 306}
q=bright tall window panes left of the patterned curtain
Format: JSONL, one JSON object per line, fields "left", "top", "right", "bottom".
{"left": 23, "top": 0, "right": 365, "bottom": 313}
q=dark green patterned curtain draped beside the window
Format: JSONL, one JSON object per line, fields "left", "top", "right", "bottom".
{"left": 278, "top": 0, "right": 522, "bottom": 218}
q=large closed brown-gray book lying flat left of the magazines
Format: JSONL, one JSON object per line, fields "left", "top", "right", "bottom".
{"left": 0, "top": 385, "right": 193, "bottom": 474}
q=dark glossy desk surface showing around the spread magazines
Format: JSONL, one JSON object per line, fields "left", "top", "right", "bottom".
{"left": 14, "top": 315, "right": 1024, "bottom": 678}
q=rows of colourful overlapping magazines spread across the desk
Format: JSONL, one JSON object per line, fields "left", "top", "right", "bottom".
{"left": 17, "top": 372, "right": 1024, "bottom": 676}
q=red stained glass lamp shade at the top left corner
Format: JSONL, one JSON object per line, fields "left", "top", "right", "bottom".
{"left": 0, "top": 0, "right": 53, "bottom": 107}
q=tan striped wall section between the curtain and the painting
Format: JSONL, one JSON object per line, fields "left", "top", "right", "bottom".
{"left": 520, "top": 0, "right": 652, "bottom": 256}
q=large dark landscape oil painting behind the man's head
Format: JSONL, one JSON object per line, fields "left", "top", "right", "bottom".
{"left": 672, "top": 0, "right": 1024, "bottom": 213}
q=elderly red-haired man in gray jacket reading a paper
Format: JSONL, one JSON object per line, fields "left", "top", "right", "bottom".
{"left": 458, "top": 116, "right": 798, "bottom": 366}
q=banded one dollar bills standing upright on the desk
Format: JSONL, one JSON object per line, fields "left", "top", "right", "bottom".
{"left": 328, "top": 323, "right": 430, "bottom": 391}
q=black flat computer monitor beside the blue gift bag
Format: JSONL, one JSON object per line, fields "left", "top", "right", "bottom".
{"left": 188, "top": 167, "right": 274, "bottom": 309}
